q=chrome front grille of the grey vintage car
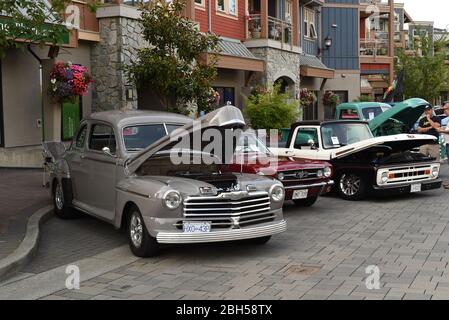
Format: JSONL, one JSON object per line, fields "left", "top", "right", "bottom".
{"left": 176, "top": 192, "right": 275, "bottom": 229}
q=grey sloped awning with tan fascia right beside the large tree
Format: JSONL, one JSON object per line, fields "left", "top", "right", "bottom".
{"left": 207, "top": 38, "right": 265, "bottom": 72}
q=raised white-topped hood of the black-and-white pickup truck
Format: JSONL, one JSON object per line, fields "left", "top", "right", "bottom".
{"left": 330, "top": 134, "right": 436, "bottom": 159}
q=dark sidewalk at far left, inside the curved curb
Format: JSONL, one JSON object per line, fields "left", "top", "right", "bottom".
{"left": 0, "top": 168, "right": 51, "bottom": 259}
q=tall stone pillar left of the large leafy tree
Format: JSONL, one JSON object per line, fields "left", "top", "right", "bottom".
{"left": 92, "top": 12, "right": 144, "bottom": 111}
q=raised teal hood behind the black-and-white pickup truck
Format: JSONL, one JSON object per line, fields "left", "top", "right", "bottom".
{"left": 369, "top": 98, "right": 429, "bottom": 133}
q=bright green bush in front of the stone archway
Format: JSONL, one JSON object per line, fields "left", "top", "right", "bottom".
{"left": 244, "top": 85, "right": 299, "bottom": 131}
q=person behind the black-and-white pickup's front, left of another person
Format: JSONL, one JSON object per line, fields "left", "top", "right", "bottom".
{"left": 418, "top": 105, "right": 441, "bottom": 161}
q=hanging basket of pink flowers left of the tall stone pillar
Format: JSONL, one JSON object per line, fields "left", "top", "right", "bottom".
{"left": 49, "top": 61, "right": 92, "bottom": 102}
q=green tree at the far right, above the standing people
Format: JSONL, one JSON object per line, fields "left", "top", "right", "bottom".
{"left": 395, "top": 35, "right": 449, "bottom": 102}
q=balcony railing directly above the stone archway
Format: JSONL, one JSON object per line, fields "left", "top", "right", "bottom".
{"left": 247, "top": 14, "right": 292, "bottom": 45}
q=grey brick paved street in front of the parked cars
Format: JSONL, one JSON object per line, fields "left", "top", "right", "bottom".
{"left": 0, "top": 166, "right": 449, "bottom": 299}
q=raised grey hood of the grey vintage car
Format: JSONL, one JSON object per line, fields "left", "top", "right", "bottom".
{"left": 126, "top": 106, "right": 245, "bottom": 174}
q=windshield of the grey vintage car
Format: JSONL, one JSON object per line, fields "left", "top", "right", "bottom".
{"left": 123, "top": 123, "right": 181, "bottom": 152}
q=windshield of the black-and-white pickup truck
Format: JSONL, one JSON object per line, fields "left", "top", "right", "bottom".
{"left": 321, "top": 123, "right": 373, "bottom": 149}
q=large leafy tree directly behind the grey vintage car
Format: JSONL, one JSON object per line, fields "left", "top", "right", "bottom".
{"left": 126, "top": 0, "right": 219, "bottom": 113}
